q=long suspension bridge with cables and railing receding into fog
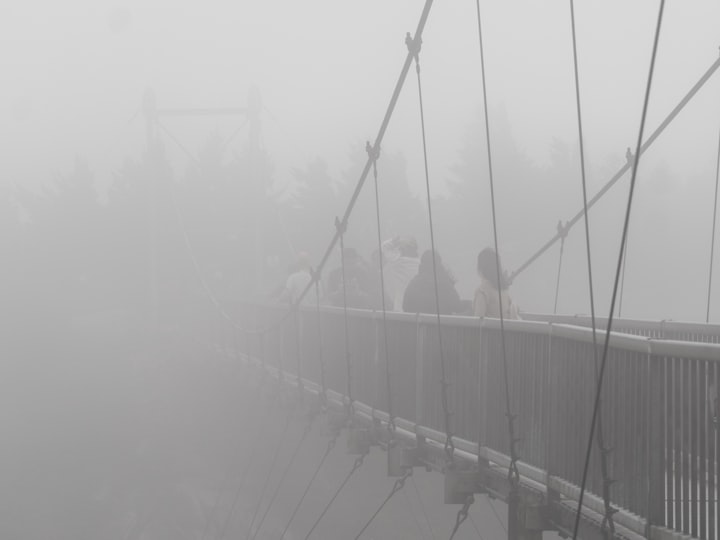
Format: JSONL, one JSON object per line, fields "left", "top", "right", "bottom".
{"left": 132, "top": 0, "right": 720, "bottom": 540}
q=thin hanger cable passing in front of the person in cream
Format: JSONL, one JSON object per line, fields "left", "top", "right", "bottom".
{"left": 475, "top": 0, "right": 520, "bottom": 486}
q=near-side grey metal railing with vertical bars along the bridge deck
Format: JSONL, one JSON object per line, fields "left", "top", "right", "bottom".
{"left": 244, "top": 306, "right": 720, "bottom": 538}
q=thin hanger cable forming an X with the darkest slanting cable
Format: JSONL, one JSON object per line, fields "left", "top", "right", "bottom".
{"left": 563, "top": 0, "right": 615, "bottom": 537}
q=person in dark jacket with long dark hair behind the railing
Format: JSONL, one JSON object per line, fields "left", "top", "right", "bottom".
{"left": 403, "top": 250, "right": 462, "bottom": 315}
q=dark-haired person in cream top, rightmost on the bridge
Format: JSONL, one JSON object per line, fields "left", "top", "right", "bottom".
{"left": 473, "top": 248, "right": 520, "bottom": 319}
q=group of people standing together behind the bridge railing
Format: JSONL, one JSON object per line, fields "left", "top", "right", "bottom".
{"left": 281, "top": 237, "right": 519, "bottom": 319}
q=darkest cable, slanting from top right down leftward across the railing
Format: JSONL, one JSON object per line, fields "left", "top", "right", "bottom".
{"left": 573, "top": 0, "right": 665, "bottom": 540}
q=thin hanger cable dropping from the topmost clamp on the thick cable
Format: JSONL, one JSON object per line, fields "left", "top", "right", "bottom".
{"left": 405, "top": 32, "right": 455, "bottom": 466}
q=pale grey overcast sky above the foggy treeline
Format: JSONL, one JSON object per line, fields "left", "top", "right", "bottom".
{"left": 0, "top": 0, "right": 720, "bottom": 318}
